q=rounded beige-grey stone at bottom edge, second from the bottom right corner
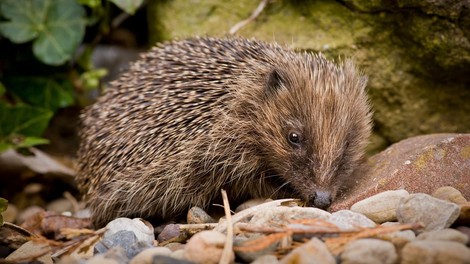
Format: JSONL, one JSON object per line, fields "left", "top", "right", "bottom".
{"left": 341, "top": 238, "right": 398, "bottom": 264}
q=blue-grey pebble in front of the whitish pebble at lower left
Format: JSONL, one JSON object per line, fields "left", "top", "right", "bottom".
{"left": 94, "top": 230, "right": 152, "bottom": 259}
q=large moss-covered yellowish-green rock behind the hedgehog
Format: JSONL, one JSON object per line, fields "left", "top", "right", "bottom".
{"left": 148, "top": 0, "right": 470, "bottom": 150}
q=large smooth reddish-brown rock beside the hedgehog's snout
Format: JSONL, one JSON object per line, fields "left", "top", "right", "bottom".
{"left": 330, "top": 134, "right": 470, "bottom": 211}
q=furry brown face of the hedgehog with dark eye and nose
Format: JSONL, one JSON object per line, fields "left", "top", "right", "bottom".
{"left": 253, "top": 60, "right": 370, "bottom": 208}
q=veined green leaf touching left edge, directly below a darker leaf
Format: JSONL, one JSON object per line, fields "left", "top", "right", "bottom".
{"left": 0, "top": 102, "right": 53, "bottom": 139}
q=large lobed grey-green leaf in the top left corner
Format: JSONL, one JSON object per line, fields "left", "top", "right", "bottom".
{"left": 0, "top": 0, "right": 86, "bottom": 65}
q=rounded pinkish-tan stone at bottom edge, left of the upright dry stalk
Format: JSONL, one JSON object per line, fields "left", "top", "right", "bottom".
{"left": 184, "top": 230, "right": 235, "bottom": 264}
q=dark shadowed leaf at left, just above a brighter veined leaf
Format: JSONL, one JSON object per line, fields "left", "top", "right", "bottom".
{"left": 5, "top": 77, "right": 75, "bottom": 112}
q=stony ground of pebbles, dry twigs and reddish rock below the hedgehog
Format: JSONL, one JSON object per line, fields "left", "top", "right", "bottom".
{"left": 0, "top": 134, "right": 470, "bottom": 263}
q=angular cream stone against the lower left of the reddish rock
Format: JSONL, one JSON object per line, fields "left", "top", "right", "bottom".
{"left": 351, "top": 190, "right": 410, "bottom": 224}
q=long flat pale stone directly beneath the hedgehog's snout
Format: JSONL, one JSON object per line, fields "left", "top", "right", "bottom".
{"left": 250, "top": 206, "right": 331, "bottom": 225}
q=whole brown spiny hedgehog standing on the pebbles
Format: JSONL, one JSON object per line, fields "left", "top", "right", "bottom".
{"left": 77, "top": 37, "right": 371, "bottom": 226}
